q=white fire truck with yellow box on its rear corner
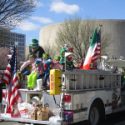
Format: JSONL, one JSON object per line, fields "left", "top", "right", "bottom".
{"left": 1, "top": 58, "right": 125, "bottom": 125}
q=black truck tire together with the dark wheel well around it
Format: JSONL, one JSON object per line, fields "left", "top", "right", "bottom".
{"left": 88, "top": 102, "right": 105, "bottom": 125}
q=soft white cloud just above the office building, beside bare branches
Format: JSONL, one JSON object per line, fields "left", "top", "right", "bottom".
{"left": 18, "top": 21, "right": 39, "bottom": 31}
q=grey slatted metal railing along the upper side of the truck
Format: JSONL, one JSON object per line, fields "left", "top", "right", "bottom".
{"left": 62, "top": 70, "right": 121, "bottom": 91}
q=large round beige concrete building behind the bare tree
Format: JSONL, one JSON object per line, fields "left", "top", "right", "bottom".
{"left": 39, "top": 19, "right": 125, "bottom": 57}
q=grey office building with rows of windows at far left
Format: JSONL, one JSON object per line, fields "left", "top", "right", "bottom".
{"left": 0, "top": 28, "right": 26, "bottom": 61}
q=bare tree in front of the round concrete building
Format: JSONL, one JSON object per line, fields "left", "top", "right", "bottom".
{"left": 56, "top": 18, "right": 108, "bottom": 61}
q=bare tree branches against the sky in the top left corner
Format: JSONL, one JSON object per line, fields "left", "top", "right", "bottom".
{"left": 0, "top": 0, "right": 36, "bottom": 27}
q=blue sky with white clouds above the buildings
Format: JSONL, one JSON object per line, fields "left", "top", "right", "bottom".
{"left": 14, "top": 0, "right": 125, "bottom": 45}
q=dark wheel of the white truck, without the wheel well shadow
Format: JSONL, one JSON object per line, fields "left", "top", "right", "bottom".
{"left": 89, "top": 105, "right": 101, "bottom": 125}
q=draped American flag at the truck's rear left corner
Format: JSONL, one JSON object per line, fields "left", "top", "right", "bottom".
{"left": 3, "top": 47, "right": 21, "bottom": 113}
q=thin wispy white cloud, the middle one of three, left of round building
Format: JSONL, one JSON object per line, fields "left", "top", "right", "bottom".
{"left": 31, "top": 16, "right": 53, "bottom": 24}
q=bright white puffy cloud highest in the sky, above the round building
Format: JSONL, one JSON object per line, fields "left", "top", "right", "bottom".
{"left": 50, "top": 1, "right": 79, "bottom": 14}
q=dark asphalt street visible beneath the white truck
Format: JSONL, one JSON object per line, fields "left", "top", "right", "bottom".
{"left": 0, "top": 112, "right": 125, "bottom": 125}
